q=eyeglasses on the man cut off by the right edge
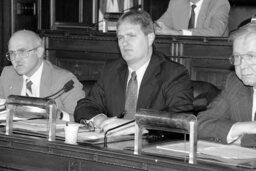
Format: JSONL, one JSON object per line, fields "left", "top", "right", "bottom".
{"left": 229, "top": 54, "right": 256, "bottom": 66}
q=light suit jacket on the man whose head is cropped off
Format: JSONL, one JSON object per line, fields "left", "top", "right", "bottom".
{"left": 159, "top": 0, "right": 230, "bottom": 36}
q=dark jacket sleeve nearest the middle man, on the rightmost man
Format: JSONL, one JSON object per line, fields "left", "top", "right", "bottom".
{"left": 197, "top": 75, "right": 236, "bottom": 143}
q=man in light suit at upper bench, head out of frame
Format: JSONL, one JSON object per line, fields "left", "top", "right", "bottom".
{"left": 156, "top": 0, "right": 230, "bottom": 36}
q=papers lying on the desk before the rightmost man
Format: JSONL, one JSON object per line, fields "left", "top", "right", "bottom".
{"left": 153, "top": 140, "right": 256, "bottom": 168}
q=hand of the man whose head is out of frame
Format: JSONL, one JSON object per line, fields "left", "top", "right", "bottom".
{"left": 155, "top": 21, "right": 182, "bottom": 35}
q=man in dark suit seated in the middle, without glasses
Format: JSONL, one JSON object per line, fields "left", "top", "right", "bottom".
{"left": 75, "top": 11, "right": 193, "bottom": 134}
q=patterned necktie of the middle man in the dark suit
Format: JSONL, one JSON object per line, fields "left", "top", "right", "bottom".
{"left": 124, "top": 71, "right": 138, "bottom": 119}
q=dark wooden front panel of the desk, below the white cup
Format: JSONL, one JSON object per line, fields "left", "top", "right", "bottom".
{"left": 0, "top": 133, "right": 252, "bottom": 171}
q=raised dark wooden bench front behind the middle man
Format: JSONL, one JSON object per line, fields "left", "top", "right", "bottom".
{"left": 41, "top": 30, "right": 233, "bottom": 88}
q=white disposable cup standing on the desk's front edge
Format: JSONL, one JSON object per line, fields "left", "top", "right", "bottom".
{"left": 64, "top": 122, "right": 80, "bottom": 144}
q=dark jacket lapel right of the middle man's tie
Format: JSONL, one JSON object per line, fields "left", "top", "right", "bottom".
{"left": 137, "top": 55, "right": 162, "bottom": 109}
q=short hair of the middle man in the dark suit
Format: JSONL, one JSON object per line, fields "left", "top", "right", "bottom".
{"left": 117, "top": 10, "right": 154, "bottom": 35}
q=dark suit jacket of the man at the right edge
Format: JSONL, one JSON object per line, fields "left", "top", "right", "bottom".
{"left": 198, "top": 72, "right": 256, "bottom": 146}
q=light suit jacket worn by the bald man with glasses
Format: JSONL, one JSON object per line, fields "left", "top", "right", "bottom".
{"left": 0, "top": 61, "right": 85, "bottom": 114}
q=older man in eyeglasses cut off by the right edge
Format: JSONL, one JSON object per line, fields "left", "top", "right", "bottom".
{"left": 198, "top": 23, "right": 256, "bottom": 147}
